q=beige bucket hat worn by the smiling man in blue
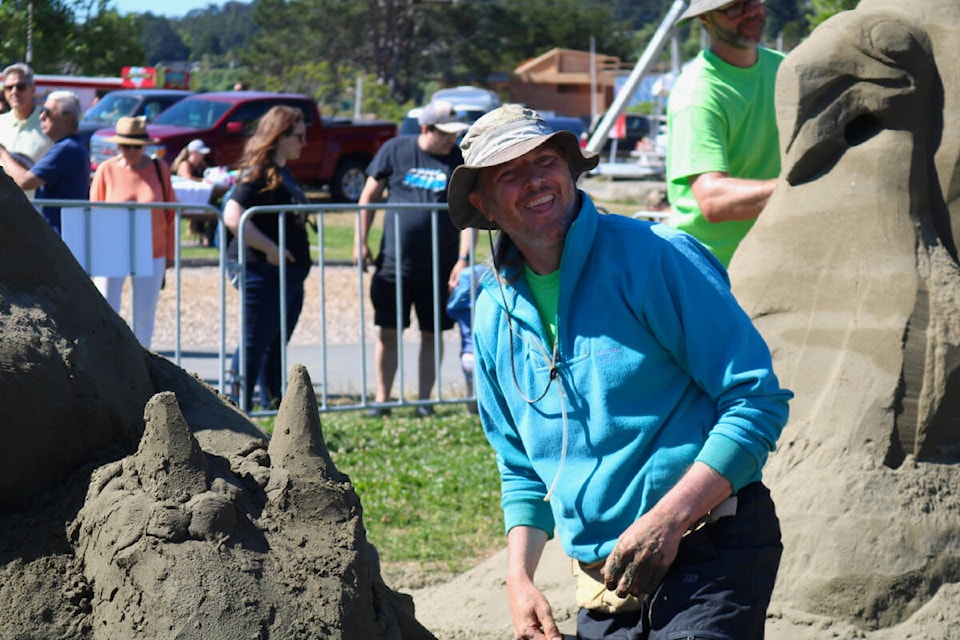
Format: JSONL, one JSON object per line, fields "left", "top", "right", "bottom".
{"left": 447, "top": 104, "right": 600, "bottom": 229}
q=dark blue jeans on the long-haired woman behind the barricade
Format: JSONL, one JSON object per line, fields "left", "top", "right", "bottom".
{"left": 231, "top": 262, "right": 310, "bottom": 411}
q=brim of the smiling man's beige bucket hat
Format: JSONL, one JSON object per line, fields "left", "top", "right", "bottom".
{"left": 447, "top": 131, "right": 600, "bottom": 230}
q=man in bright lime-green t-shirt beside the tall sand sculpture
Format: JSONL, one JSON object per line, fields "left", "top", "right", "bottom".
{"left": 667, "top": 0, "right": 783, "bottom": 266}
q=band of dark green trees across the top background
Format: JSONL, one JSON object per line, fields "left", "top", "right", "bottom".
{"left": 0, "top": 0, "right": 856, "bottom": 115}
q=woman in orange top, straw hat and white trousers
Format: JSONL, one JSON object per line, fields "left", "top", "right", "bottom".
{"left": 90, "top": 117, "right": 177, "bottom": 349}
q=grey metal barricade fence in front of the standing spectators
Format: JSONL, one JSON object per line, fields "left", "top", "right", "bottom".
{"left": 32, "top": 199, "right": 475, "bottom": 416}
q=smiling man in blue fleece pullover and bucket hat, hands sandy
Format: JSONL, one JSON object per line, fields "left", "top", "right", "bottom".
{"left": 449, "top": 105, "right": 792, "bottom": 640}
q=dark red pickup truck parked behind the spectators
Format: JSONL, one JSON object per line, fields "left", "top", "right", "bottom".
{"left": 90, "top": 91, "right": 397, "bottom": 202}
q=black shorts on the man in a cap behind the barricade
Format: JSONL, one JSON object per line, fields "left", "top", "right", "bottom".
{"left": 370, "top": 270, "right": 454, "bottom": 333}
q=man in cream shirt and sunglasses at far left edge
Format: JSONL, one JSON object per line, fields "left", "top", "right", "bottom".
{"left": 0, "top": 62, "right": 53, "bottom": 198}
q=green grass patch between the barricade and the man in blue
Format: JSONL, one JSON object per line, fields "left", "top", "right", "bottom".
{"left": 323, "top": 405, "right": 505, "bottom": 573}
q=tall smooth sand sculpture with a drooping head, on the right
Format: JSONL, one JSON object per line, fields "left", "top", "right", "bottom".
{"left": 731, "top": 0, "right": 960, "bottom": 637}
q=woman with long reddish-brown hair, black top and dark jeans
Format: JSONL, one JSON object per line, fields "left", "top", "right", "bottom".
{"left": 223, "top": 106, "right": 310, "bottom": 410}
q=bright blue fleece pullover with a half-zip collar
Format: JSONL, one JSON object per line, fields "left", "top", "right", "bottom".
{"left": 474, "top": 193, "right": 793, "bottom": 562}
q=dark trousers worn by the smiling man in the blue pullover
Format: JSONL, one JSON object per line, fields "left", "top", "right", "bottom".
{"left": 577, "top": 482, "right": 783, "bottom": 640}
